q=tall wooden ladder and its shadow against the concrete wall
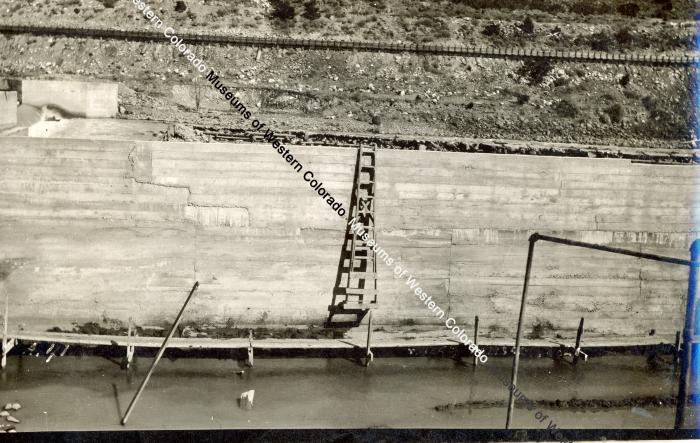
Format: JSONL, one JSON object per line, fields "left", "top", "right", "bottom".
{"left": 327, "top": 146, "right": 377, "bottom": 327}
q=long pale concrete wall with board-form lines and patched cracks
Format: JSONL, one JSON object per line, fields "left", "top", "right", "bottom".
{"left": 0, "top": 138, "right": 696, "bottom": 335}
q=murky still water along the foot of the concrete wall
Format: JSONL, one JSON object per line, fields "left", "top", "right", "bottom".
{"left": 0, "top": 356, "right": 694, "bottom": 431}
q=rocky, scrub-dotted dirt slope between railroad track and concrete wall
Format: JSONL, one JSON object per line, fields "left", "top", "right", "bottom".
{"left": 0, "top": 31, "right": 694, "bottom": 149}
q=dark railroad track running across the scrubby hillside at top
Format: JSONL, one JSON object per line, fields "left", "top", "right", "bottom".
{"left": 0, "top": 24, "right": 700, "bottom": 66}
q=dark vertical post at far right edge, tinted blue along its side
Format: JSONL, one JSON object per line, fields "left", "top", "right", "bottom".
{"left": 673, "top": 240, "right": 700, "bottom": 429}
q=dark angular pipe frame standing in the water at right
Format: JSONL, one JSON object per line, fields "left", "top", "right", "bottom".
{"left": 506, "top": 232, "right": 700, "bottom": 429}
